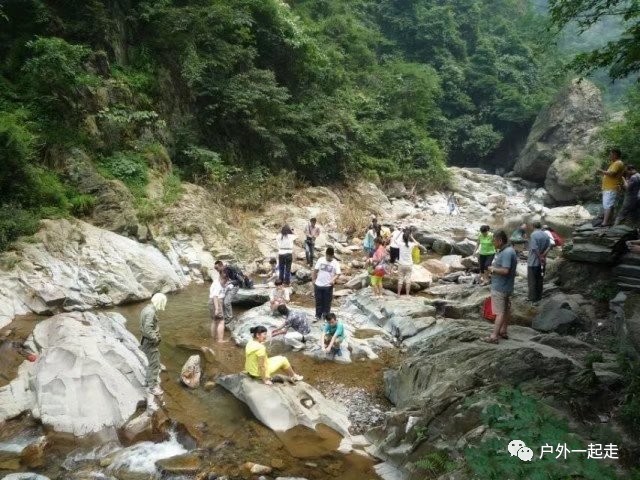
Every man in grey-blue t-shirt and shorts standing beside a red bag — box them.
[482,230,516,343]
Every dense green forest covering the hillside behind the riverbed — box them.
[0,0,592,247]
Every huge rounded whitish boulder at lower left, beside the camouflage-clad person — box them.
[0,312,147,437]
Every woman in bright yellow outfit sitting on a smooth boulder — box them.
[244,325,303,385]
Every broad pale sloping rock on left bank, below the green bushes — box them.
[0,220,188,326]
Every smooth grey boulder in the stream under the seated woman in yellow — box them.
[216,374,351,437]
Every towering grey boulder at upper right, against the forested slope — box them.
[514,80,605,183]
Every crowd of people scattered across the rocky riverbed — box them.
[140,149,640,408]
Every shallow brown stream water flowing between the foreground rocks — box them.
[0,285,399,480]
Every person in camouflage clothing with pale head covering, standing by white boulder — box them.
[140,293,167,411]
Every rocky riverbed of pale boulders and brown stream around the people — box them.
[0,168,636,480]
